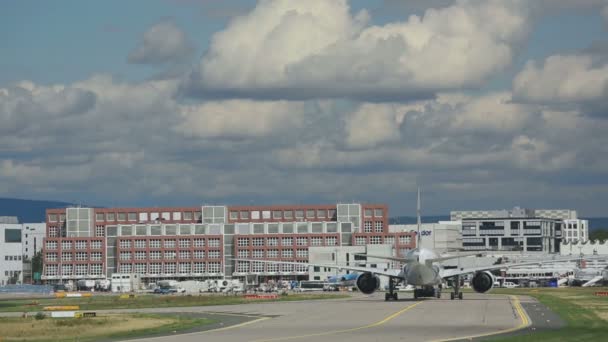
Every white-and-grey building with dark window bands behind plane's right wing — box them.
[450,207,564,253]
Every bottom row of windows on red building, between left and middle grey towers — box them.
[118,261,222,274]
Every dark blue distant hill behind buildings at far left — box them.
[0,198,73,223]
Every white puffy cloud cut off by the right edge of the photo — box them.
[513,55,608,104]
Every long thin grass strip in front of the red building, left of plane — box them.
[0,294,349,312]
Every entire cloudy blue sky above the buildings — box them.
[0,0,608,217]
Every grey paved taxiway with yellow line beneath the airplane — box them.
[121,293,530,342]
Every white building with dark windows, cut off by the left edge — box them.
[0,223,23,286]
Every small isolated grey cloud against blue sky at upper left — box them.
[127,20,194,64]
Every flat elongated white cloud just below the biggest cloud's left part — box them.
[175,100,305,138]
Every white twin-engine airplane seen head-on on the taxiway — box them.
[233,189,596,301]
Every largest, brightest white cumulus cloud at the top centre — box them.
[183,0,529,100]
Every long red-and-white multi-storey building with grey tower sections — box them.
[42,203,415,283]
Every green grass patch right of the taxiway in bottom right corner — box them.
[490,288,608,342]
